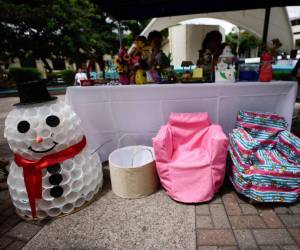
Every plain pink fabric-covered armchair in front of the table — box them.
[153,113,228,203]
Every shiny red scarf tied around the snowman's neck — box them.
[15,136,86,218]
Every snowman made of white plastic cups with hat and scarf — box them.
[4,81,103,219]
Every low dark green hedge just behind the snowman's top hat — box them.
[9,67,42,82]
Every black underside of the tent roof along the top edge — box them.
[99,0,299,20]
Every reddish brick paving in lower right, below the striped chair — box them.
[195,180,300,249]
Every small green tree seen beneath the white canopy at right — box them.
[226,31,261,57]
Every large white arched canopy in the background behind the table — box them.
[141,7,294,51]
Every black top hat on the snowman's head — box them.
[14,80,57,106]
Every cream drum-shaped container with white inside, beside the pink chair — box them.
[108,146,159,198]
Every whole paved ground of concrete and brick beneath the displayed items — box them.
[0,98,300,250]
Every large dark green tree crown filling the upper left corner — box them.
[0,0,118,72]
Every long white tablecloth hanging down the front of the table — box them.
[66,82,297,161]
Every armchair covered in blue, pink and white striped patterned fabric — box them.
[229,111,300,202]
